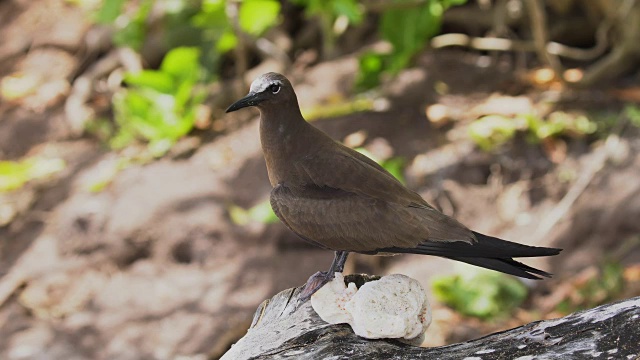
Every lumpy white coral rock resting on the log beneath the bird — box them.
[311,273,431,343]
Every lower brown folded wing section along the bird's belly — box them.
[271,185,429,253]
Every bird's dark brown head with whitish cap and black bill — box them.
[227,72,297,112]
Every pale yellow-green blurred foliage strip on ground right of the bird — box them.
[469,111,598,151]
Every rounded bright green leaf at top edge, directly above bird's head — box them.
[238,0,280,36]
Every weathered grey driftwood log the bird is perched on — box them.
[222,275,640,360]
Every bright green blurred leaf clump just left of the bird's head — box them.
[111,47,206,156]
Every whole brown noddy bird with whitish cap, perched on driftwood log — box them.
[227,73,561,300]
